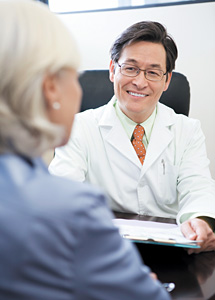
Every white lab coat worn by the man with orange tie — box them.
[49,98,215,222]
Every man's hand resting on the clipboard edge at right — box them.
[181,218,215,254]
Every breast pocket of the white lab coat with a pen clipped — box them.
[158,159,179,204]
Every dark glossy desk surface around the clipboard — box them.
[114,212,215,300]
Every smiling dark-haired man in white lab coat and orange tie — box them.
[50,22,215,252]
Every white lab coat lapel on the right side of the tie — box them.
[142,103,175,175]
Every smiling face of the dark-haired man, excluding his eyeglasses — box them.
[110,41,172,123]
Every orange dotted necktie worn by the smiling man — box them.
[131,125,146,164]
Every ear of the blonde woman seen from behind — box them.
[42,75,60,107]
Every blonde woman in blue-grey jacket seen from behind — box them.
[0,0,169,300]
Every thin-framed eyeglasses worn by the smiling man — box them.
[117,63,167,81]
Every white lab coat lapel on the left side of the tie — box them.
[99,98,142,168]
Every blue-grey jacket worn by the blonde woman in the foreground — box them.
[0,154,169,300]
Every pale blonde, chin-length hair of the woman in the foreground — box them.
[0,0,79,156]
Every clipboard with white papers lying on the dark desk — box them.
[113,219,200,248]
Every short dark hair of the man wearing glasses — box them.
[110,21,178,73]
